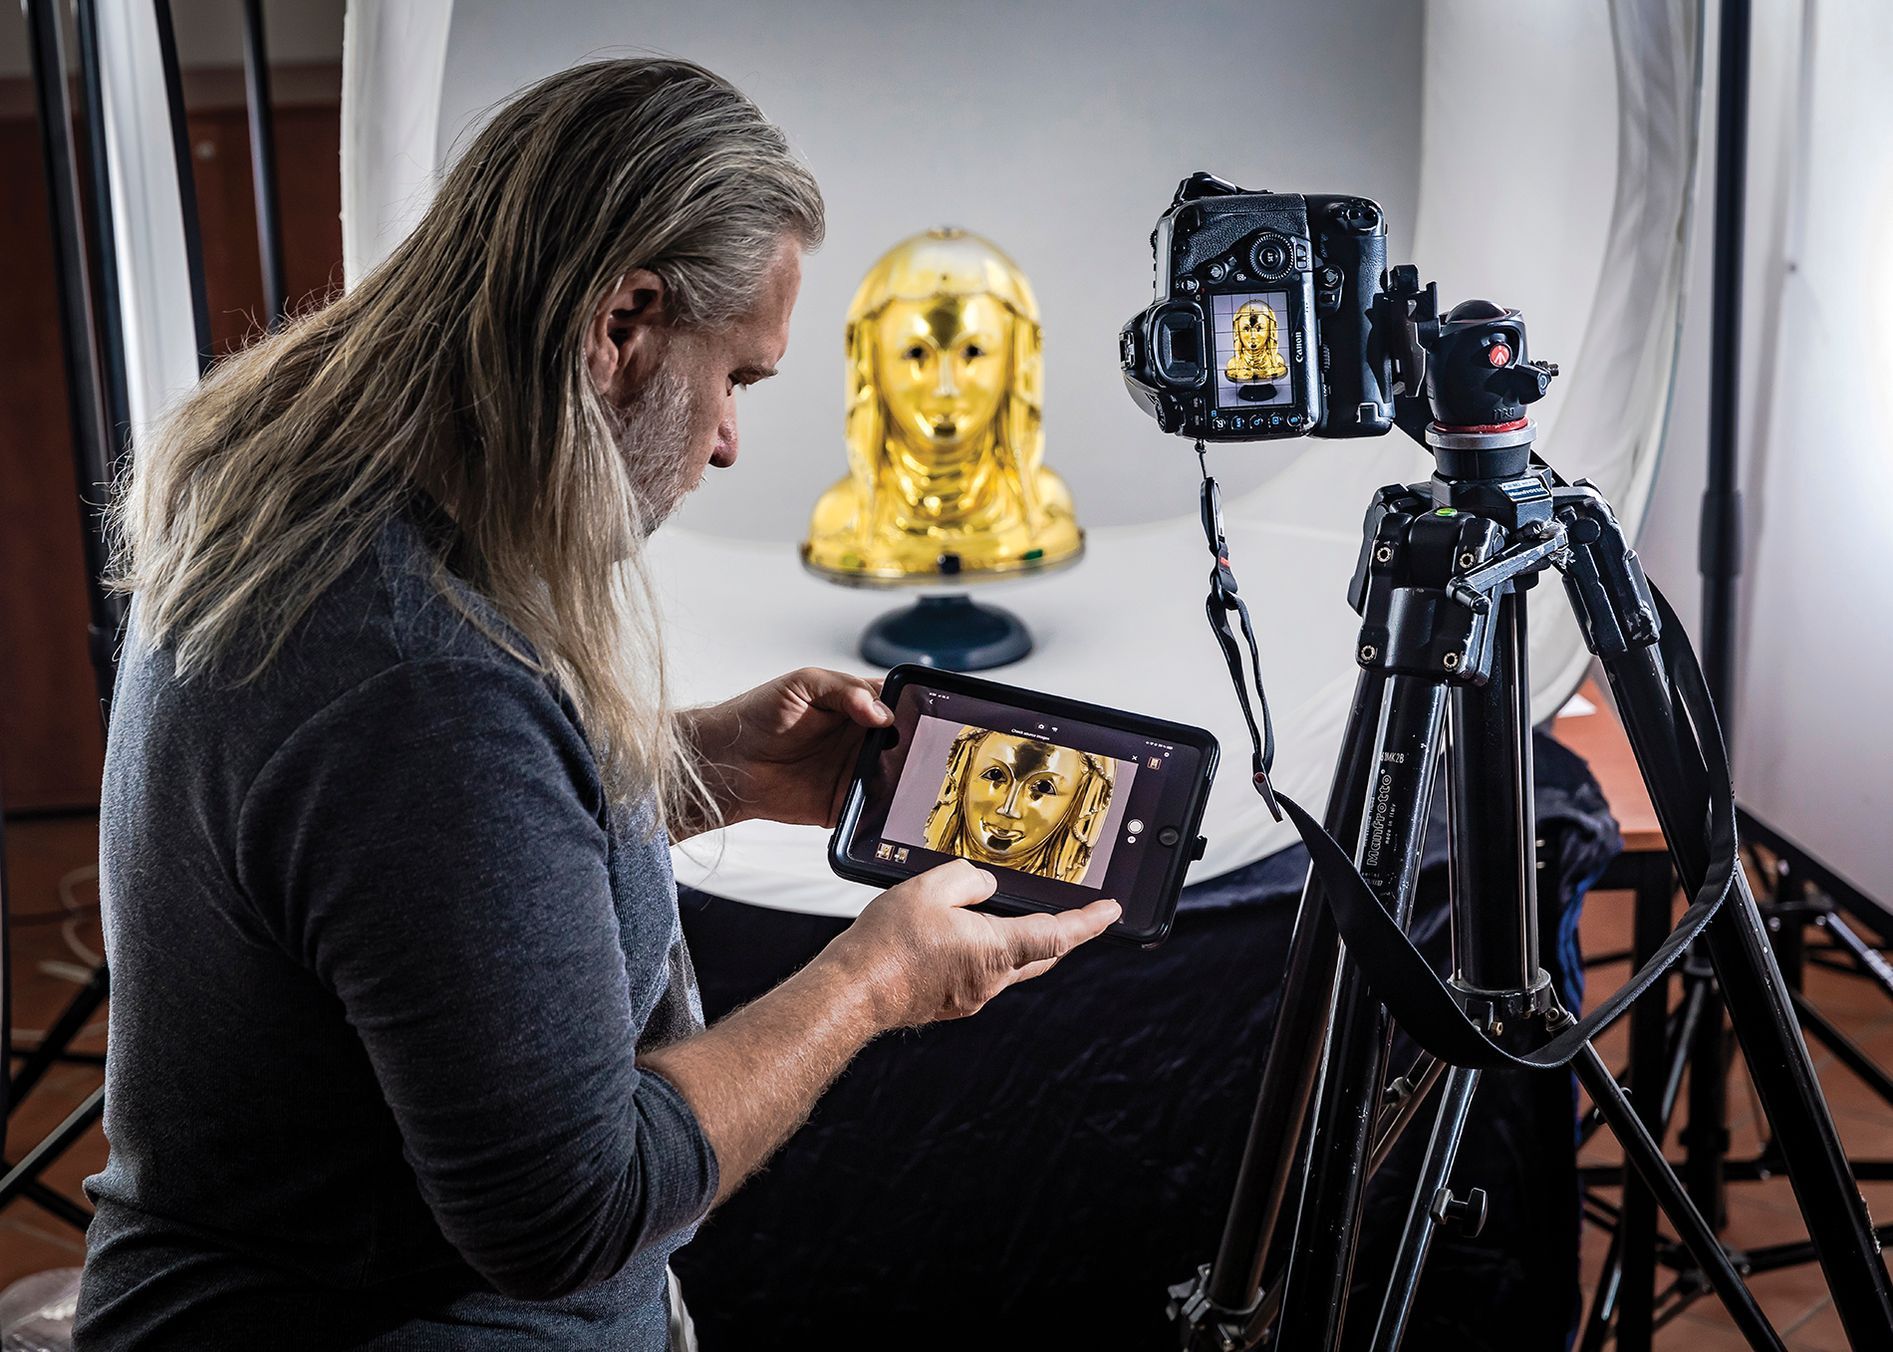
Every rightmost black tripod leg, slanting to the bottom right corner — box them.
[1603,648,1893,1346]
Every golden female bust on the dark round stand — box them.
[803,229,1085,585]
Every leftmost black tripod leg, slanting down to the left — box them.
[1206,672,1386,1310]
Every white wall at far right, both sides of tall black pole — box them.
[1639,0,1893,903]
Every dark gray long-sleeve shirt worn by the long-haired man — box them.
[76,517,716,1350]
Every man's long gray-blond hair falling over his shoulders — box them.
[114,59,823,822]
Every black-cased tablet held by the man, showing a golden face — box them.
[829,667,1219,947]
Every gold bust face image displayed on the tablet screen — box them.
[924,727,1117,882]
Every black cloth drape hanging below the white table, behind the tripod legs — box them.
[674,735,1620,1352]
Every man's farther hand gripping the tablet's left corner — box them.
[674,667,893,839]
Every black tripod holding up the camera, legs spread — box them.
[1172,287,1893,1352]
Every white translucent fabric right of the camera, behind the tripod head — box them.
[1414,0,1702,720]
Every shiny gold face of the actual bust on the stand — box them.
[875,295,1011,458]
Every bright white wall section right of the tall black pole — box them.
[1732,4,1893,905]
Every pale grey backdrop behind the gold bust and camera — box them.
[441,0,1422,537]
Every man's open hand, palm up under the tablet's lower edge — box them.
[816,860,1123,1028]
